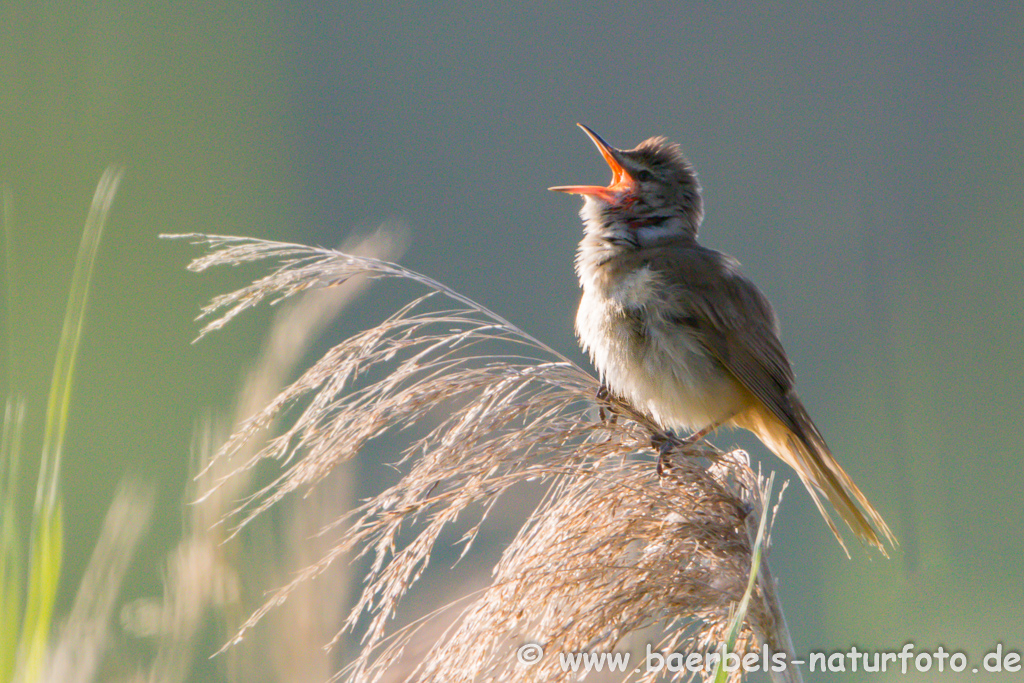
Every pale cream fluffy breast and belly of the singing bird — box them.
[577,266,748,430]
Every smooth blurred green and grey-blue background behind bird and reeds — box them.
[0,0,1024,681]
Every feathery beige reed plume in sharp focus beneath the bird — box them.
[173,234,800,682]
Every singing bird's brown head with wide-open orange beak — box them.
[551,124,703,247]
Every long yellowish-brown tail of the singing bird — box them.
[742,396,898,557]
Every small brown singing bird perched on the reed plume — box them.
[550,124,897,556]
